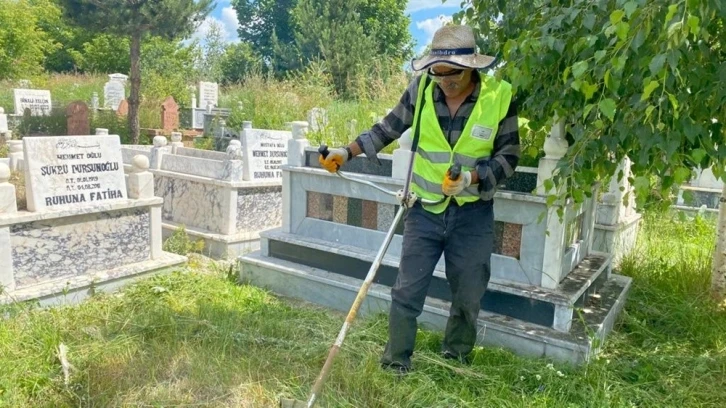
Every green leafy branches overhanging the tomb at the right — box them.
[464,0,726,291]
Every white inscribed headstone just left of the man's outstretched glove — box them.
[242,129,292,181]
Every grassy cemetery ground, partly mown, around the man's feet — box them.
[0,209,726,407]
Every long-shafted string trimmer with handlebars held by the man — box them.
[280,145,461,408]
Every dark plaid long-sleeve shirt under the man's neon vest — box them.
[356,73,521,201]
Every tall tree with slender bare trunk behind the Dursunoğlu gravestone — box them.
[59,0,214,143]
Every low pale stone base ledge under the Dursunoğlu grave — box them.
[0,252,187,307]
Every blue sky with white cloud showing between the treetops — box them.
[194,0,461,53]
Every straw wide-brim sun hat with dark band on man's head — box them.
[411,25,496,71]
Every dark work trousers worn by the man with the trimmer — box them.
[381,200,494,368]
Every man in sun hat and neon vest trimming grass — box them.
[320,25,520,373]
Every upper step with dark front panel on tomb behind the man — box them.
[260,229,610,332]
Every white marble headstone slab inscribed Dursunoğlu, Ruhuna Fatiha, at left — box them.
[23,135,127,211]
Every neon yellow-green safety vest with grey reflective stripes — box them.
[411,73,512,213]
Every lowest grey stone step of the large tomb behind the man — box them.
[239,251,631,364]
